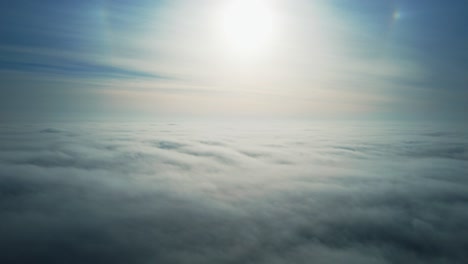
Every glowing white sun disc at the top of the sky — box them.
[218,0,275,56]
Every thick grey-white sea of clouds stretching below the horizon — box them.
[0,122,468,264]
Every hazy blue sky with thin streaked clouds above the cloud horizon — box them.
[0,0,468,120]
